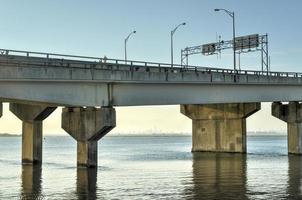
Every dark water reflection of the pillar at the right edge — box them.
[287,155,302,199]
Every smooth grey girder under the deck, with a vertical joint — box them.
[0,80,302,107]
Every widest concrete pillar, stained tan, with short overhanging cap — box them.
[181,103,261,153]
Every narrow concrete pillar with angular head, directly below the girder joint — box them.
[62,107,116,167]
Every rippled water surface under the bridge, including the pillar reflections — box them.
[0,136,302,199]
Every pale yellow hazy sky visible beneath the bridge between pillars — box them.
[0,103,287,135]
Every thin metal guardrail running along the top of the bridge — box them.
[0,49,302,78]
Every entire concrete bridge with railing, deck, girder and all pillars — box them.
[0,49,302,167]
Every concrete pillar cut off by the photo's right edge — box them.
[272,102,302,154]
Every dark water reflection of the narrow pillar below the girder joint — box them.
[77,168,97,199]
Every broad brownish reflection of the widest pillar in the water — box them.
[186,153,247,199]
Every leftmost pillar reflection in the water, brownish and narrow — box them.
[21,165,43,199]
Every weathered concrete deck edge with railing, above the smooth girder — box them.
[0,49,302,84]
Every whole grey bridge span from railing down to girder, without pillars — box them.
[0,49,302,106]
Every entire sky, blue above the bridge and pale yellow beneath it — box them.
[0,0,302,134]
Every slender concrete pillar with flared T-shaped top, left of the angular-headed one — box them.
[9,103,56,164]
